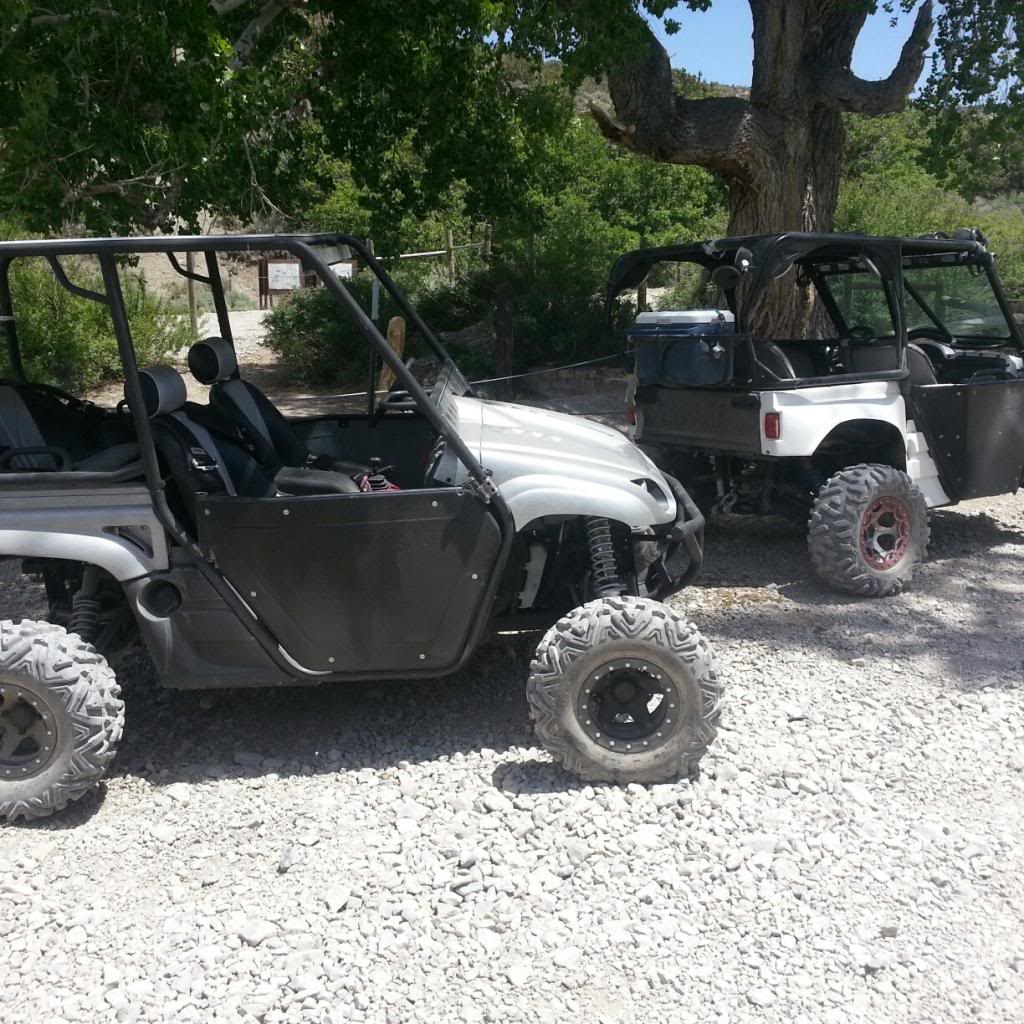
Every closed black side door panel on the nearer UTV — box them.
[198,487,503,675]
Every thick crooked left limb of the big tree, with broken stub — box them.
[590,17,750,176]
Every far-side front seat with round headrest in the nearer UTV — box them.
[188,338,370,476]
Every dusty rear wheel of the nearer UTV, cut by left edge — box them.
[0,620,124,821]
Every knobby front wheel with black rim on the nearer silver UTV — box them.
[526,597,722,783]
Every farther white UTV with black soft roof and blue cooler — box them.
[608,229,1024,596]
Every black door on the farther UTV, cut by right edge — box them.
[911,380,1024,501]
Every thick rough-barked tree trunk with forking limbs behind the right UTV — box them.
[591,0,932,339]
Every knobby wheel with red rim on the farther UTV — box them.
[807,464,929,597]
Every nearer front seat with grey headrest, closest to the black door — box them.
[139,367,359,526]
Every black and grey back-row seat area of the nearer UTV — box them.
[0,381,142,471]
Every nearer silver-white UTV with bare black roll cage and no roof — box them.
[0,236,721,819]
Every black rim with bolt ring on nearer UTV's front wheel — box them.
[577,657,680,754]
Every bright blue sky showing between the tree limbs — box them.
[656,0,928,86]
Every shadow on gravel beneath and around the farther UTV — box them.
[692,506,1024,691]
